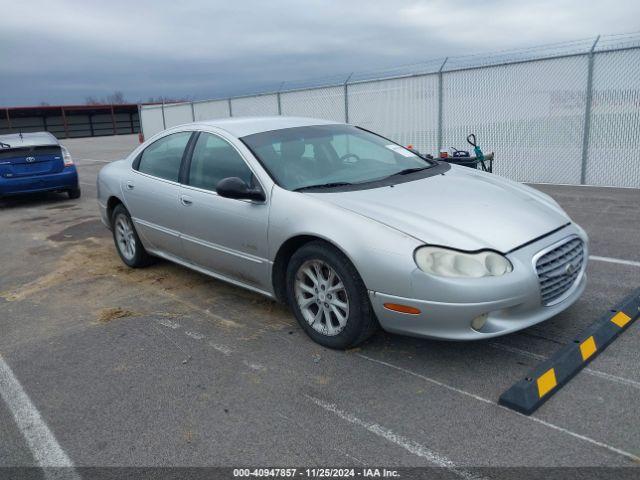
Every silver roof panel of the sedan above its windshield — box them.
[195,116,340,138]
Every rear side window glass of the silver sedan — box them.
[138,132,192,182]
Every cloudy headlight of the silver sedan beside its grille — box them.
[415,247,513,278]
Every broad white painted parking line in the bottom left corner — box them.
[0,356,80,479]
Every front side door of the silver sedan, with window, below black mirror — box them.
[180,132,270,291]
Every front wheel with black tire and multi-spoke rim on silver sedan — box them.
[286,241,378,350]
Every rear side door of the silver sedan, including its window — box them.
[122,131,193,257]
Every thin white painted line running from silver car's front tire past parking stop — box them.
[355,353,640,462]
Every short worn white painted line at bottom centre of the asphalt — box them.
[305,394,482,479]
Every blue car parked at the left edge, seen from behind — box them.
[0,132,80,198]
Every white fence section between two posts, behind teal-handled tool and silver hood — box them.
[442,55,587,184]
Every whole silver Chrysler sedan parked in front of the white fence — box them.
[98,117,588,348]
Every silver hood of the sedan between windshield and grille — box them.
[310,166,571,253]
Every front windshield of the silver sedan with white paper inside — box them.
[241,125,435,190]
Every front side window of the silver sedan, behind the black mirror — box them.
[187,132,253,191]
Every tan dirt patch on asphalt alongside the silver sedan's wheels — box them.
[0,234,295,340]
